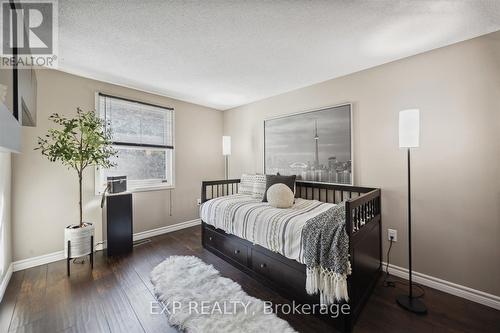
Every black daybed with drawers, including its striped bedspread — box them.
[201,179,382,332]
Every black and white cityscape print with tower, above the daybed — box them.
[264,104,352,184]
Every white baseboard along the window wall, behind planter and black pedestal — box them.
[11,219,201,274]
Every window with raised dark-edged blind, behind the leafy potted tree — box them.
[96,94,174,192]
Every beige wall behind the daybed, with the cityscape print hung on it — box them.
[224,32,500,295]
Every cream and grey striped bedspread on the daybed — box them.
[200,194,335,263]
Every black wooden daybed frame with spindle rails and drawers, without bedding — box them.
[201,179,382,332]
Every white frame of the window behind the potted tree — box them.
[95,91,175,195]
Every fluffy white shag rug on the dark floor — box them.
[151,256,295,333]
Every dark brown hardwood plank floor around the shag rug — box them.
[0,227,500,333]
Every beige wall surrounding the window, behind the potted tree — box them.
[12,70,224,260]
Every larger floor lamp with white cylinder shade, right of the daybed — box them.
[396,109,427,314]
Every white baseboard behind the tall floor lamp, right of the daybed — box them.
[382,262,500,310]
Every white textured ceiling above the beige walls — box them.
[59,0,500,110]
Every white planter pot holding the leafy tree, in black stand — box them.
[64,222,94,258]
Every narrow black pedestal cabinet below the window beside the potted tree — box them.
[106,193,133,256]
